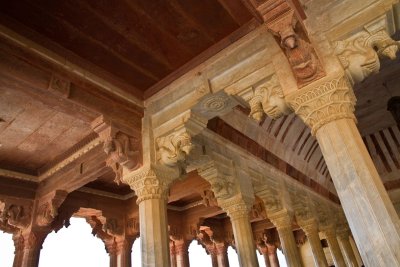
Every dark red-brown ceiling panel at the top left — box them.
[0,0,254,98]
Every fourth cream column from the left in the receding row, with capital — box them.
[300,220,328,267]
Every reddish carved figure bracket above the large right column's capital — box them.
[267,10,325,87]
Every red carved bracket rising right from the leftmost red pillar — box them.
[36,190,68,226]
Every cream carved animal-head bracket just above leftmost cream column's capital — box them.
[156,131,193,167]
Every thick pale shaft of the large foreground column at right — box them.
[316,119,400,266]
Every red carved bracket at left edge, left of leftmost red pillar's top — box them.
[0,201,32,229]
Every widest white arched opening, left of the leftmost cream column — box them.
[39,218,110,267]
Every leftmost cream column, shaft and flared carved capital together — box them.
[124,165,180,267]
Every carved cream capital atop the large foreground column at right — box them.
[286,76,356,135]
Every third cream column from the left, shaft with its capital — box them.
[268,214,302,267]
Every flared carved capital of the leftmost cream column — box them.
[123,164,181,204]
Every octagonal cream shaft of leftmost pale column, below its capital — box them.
[139,197,170,267]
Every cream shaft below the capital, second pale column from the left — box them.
[231,217,258,267]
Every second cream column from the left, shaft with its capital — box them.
[222,201,258,267]
